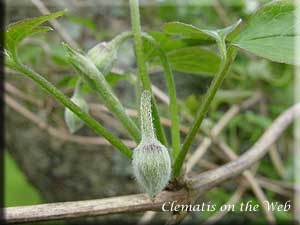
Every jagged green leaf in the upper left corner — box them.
[5,10,66,59]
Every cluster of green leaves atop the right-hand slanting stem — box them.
[162,0,300,75]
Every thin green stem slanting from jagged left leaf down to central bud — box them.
[14,63,132,159]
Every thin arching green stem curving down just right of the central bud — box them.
[142,33,180,160]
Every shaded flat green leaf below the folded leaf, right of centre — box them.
[156,47,221,75]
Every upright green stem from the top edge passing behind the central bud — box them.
[129,0,167,145]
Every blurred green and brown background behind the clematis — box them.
[5,0,293,223]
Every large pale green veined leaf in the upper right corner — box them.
[232,0,300,64]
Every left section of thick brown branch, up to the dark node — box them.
[4,190,188,223]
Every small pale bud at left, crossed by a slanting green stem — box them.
[65,81,89,134]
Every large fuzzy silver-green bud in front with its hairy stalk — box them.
[132,91,171,198]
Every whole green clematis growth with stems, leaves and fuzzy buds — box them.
[4,0,299,198]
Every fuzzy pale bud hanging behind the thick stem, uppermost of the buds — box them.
[87,41,118,75]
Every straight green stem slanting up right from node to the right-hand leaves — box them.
[173,46,237,177]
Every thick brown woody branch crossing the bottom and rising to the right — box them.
[4,104,300,223]
